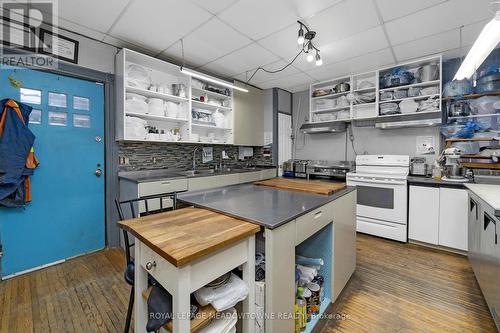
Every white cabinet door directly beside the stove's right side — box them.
[408,186,439,245]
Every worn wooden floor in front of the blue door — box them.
[0,250,130,333]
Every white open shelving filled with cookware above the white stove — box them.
[309,56,442,123]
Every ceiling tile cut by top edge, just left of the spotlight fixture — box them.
[219,0,299,40]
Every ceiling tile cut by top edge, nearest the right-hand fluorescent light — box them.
[386,0,492,45]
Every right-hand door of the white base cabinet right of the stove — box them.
[439,188,468,251]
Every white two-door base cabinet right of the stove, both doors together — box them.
[408,186,469,251]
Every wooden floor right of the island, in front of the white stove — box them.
[315,234,497,333]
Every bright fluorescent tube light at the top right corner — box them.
[453,1,500,80]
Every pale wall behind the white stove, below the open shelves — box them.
[293,91,440,162]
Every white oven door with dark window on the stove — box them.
[347,176,407,224]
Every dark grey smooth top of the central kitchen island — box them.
[178,184,356,229]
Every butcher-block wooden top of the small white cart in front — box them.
[118,208,260,267]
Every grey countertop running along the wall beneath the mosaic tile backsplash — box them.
[118,166,276,183]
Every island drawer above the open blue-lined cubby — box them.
[295,203,333,244]
